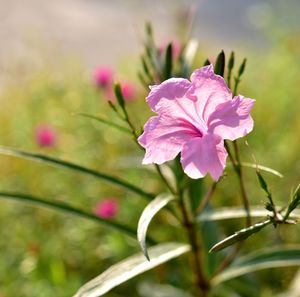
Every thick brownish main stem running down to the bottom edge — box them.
[178,188,209,297]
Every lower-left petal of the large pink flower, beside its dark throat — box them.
[138,116,201,164]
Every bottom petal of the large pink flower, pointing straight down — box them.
[181,134,227,181]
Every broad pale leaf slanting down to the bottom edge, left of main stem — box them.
[74,242,190,297]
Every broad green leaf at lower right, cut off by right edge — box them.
[212,245,300,285]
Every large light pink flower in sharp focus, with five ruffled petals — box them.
[138,65,255,180]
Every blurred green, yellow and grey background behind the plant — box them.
[0,0,300,297]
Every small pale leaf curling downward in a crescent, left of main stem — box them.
[137,194,175,261]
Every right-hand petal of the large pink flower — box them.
[208,95,255,140]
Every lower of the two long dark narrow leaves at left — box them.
[0,192,146,243]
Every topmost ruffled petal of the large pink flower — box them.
[187,64,232,122]
